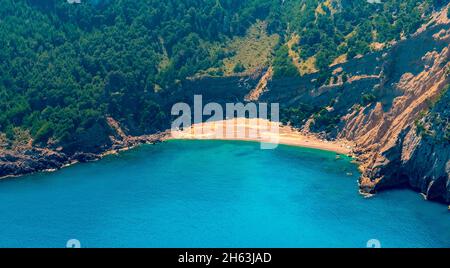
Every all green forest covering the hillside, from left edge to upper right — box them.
[0,0,441,150]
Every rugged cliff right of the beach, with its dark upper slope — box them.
[260,6,450,203]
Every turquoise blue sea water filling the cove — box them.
[0,141,450,247]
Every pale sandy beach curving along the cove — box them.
[168,118,353,155]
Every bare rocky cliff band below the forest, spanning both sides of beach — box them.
[0,1,450,203]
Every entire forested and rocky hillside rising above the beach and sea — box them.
[0,0,450,203]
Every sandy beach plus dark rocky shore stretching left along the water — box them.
[0,118,354,179]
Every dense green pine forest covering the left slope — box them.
[0,0,278,151]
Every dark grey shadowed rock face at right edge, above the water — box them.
[373,91,450,203]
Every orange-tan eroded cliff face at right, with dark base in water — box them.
[350,25,450,203]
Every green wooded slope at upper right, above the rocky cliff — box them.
[269,0,443,77]
